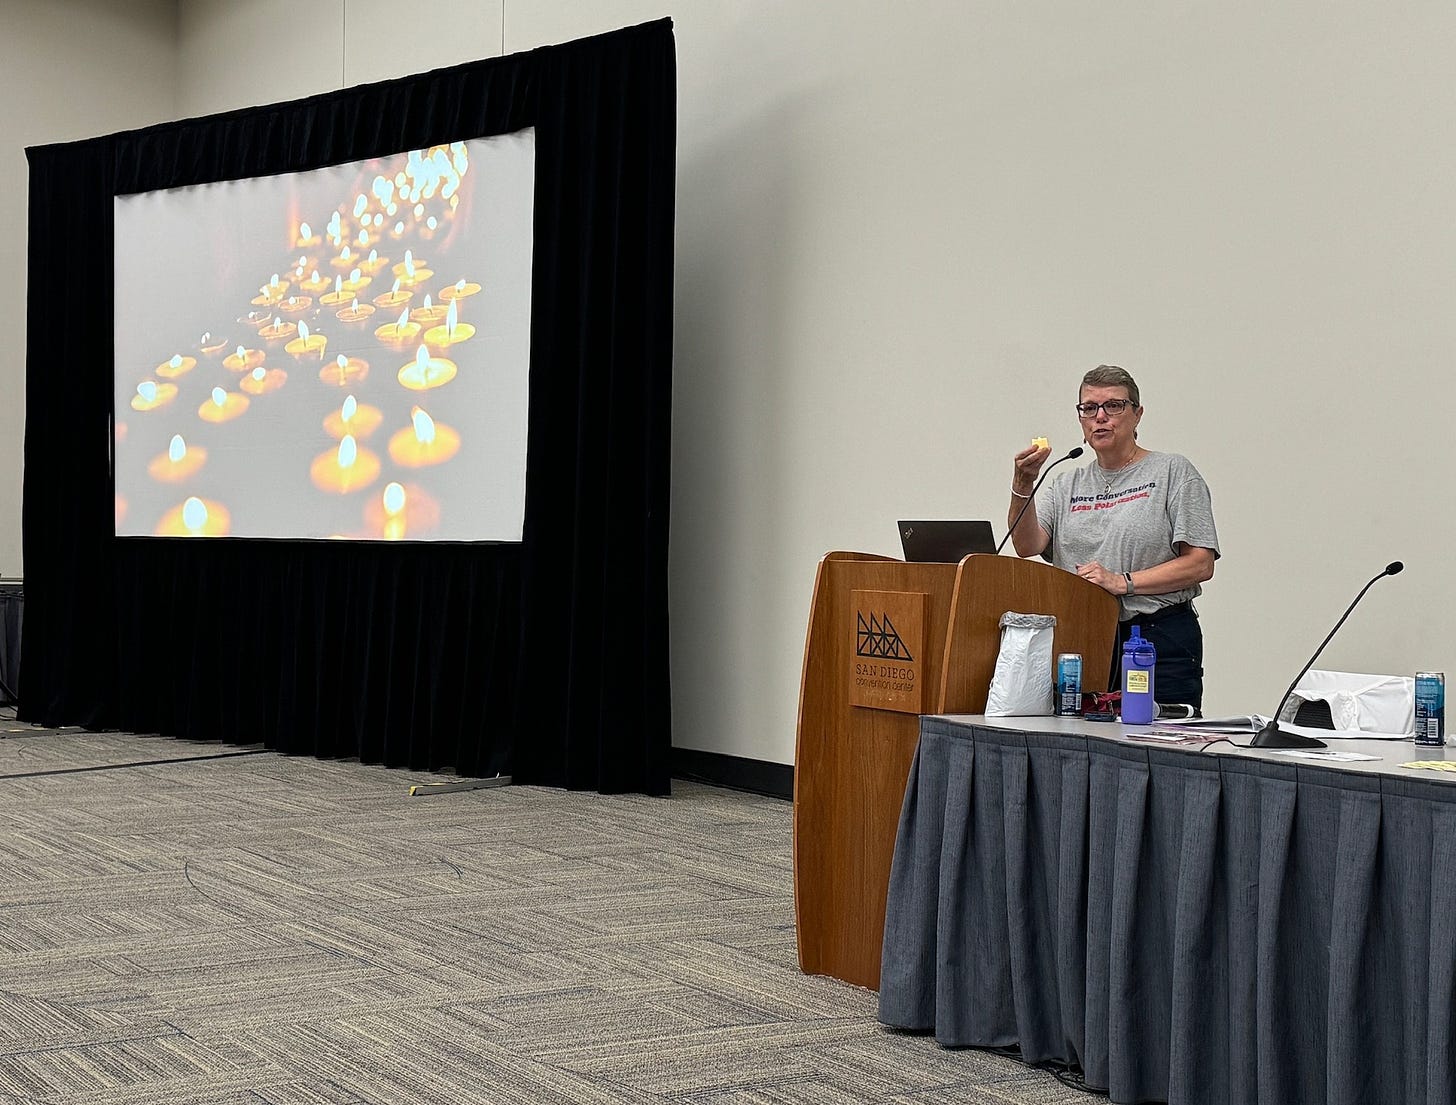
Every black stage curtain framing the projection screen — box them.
[20,20,677,793]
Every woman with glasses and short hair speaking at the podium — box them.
[1006,364,1219,708]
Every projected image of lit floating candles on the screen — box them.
[114,130,534,542]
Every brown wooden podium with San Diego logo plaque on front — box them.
[794,552,1118,990]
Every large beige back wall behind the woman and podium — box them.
[0,0,1456,761]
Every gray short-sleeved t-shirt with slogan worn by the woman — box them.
[1037,453,1220,620]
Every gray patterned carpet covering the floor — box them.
[0,721,1096,1105]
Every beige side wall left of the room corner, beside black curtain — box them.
[0,0,176,577]
